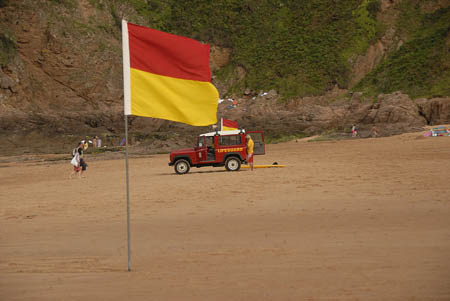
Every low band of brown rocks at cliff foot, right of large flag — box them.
[220,92,450,137]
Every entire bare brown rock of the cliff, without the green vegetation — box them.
[0,0,450,154]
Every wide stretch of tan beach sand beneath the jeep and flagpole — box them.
[0,133,450,300]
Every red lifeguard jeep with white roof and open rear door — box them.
[169,130,266,175]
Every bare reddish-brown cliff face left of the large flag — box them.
[0,1,122,134]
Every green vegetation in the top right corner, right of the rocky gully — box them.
[355,1,450,98]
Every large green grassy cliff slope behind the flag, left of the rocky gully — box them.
[117,0,380,98]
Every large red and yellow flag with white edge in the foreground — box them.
[122,20,219,126]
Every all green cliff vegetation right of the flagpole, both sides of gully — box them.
[129,0,450,98]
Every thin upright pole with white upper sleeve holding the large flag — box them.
[122,20,131,271]
